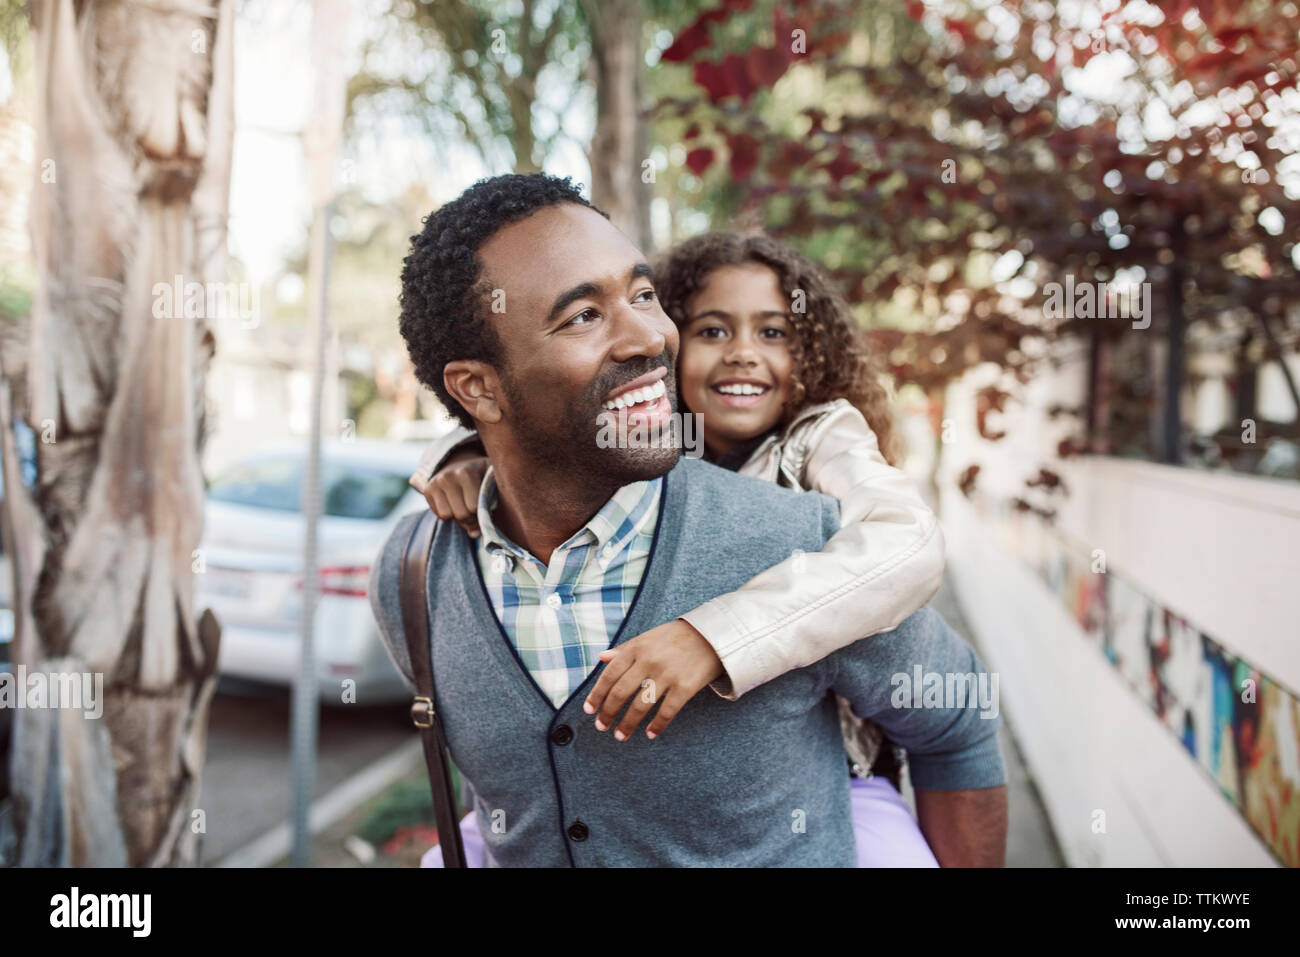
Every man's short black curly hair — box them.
[398,173,608,429]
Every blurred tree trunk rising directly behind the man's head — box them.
[582,0,654,252]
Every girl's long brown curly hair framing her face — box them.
[654,233,900,465]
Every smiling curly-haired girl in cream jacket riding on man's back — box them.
[411,233,944,867]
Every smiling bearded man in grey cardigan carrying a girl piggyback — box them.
[369,174,1005,866]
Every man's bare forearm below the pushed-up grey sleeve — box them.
[917,787,1006,867]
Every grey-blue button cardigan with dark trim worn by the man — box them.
[369,458,1006,867]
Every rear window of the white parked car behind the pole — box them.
[208,456,410,519]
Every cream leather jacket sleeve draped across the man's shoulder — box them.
[680,403,944,700]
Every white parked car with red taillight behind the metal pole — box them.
[195,438,428,705]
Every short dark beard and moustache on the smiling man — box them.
[503,352,681,488]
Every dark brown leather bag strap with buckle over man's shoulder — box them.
[398,510,467,867]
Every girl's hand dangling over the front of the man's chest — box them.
[582,619,723,741]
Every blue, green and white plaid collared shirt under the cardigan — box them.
[476,467,663,707]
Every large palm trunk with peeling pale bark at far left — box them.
[0,0,234,866]
